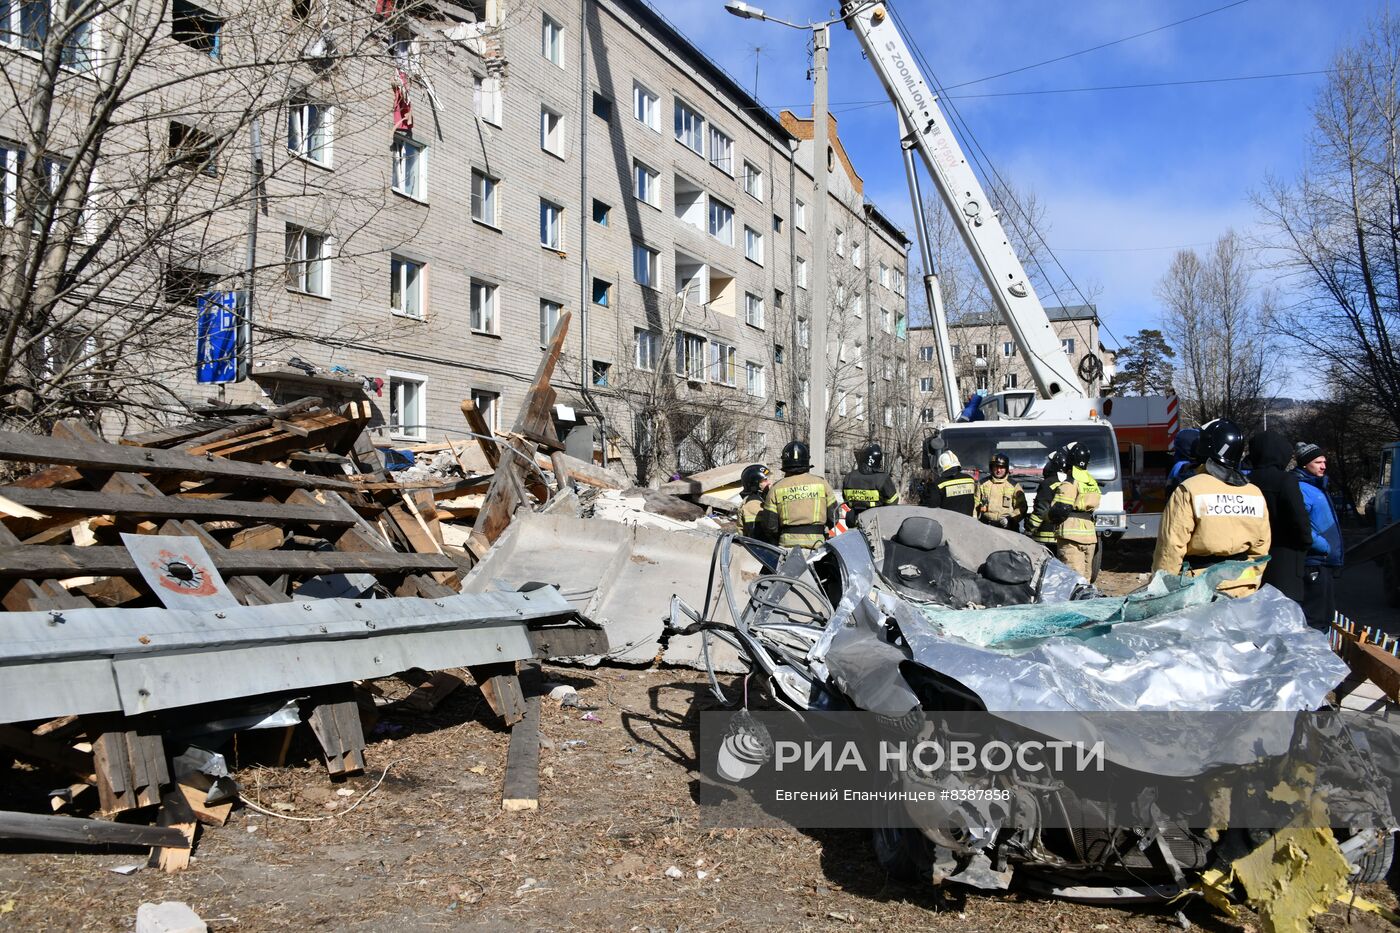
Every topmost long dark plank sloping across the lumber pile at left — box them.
[0,431,354,492]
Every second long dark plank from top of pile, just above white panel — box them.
[4,488,350,525]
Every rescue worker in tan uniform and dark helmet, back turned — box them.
[1152,417,1271,597]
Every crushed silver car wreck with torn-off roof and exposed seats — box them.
[661,506,1400,913]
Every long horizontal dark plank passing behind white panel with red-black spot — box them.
[0,540,459,577]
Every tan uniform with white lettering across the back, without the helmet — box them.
[1152,472,1273,597]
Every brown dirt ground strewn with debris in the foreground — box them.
[0,537,1396,933]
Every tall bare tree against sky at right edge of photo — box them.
[1256,10,1400,433]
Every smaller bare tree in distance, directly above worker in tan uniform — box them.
[1156,231,1275,429]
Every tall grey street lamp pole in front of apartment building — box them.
[724,0,833,475]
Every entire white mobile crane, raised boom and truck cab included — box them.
[841,1,1127,540]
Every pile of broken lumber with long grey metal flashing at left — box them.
[0,322,616,870]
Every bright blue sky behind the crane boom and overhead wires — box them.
[654,0,1385,355]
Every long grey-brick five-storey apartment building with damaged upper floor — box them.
[0,0,917,479]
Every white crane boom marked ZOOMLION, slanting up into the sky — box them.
[843,1,1086,399]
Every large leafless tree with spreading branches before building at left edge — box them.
[0,0,482,430]
